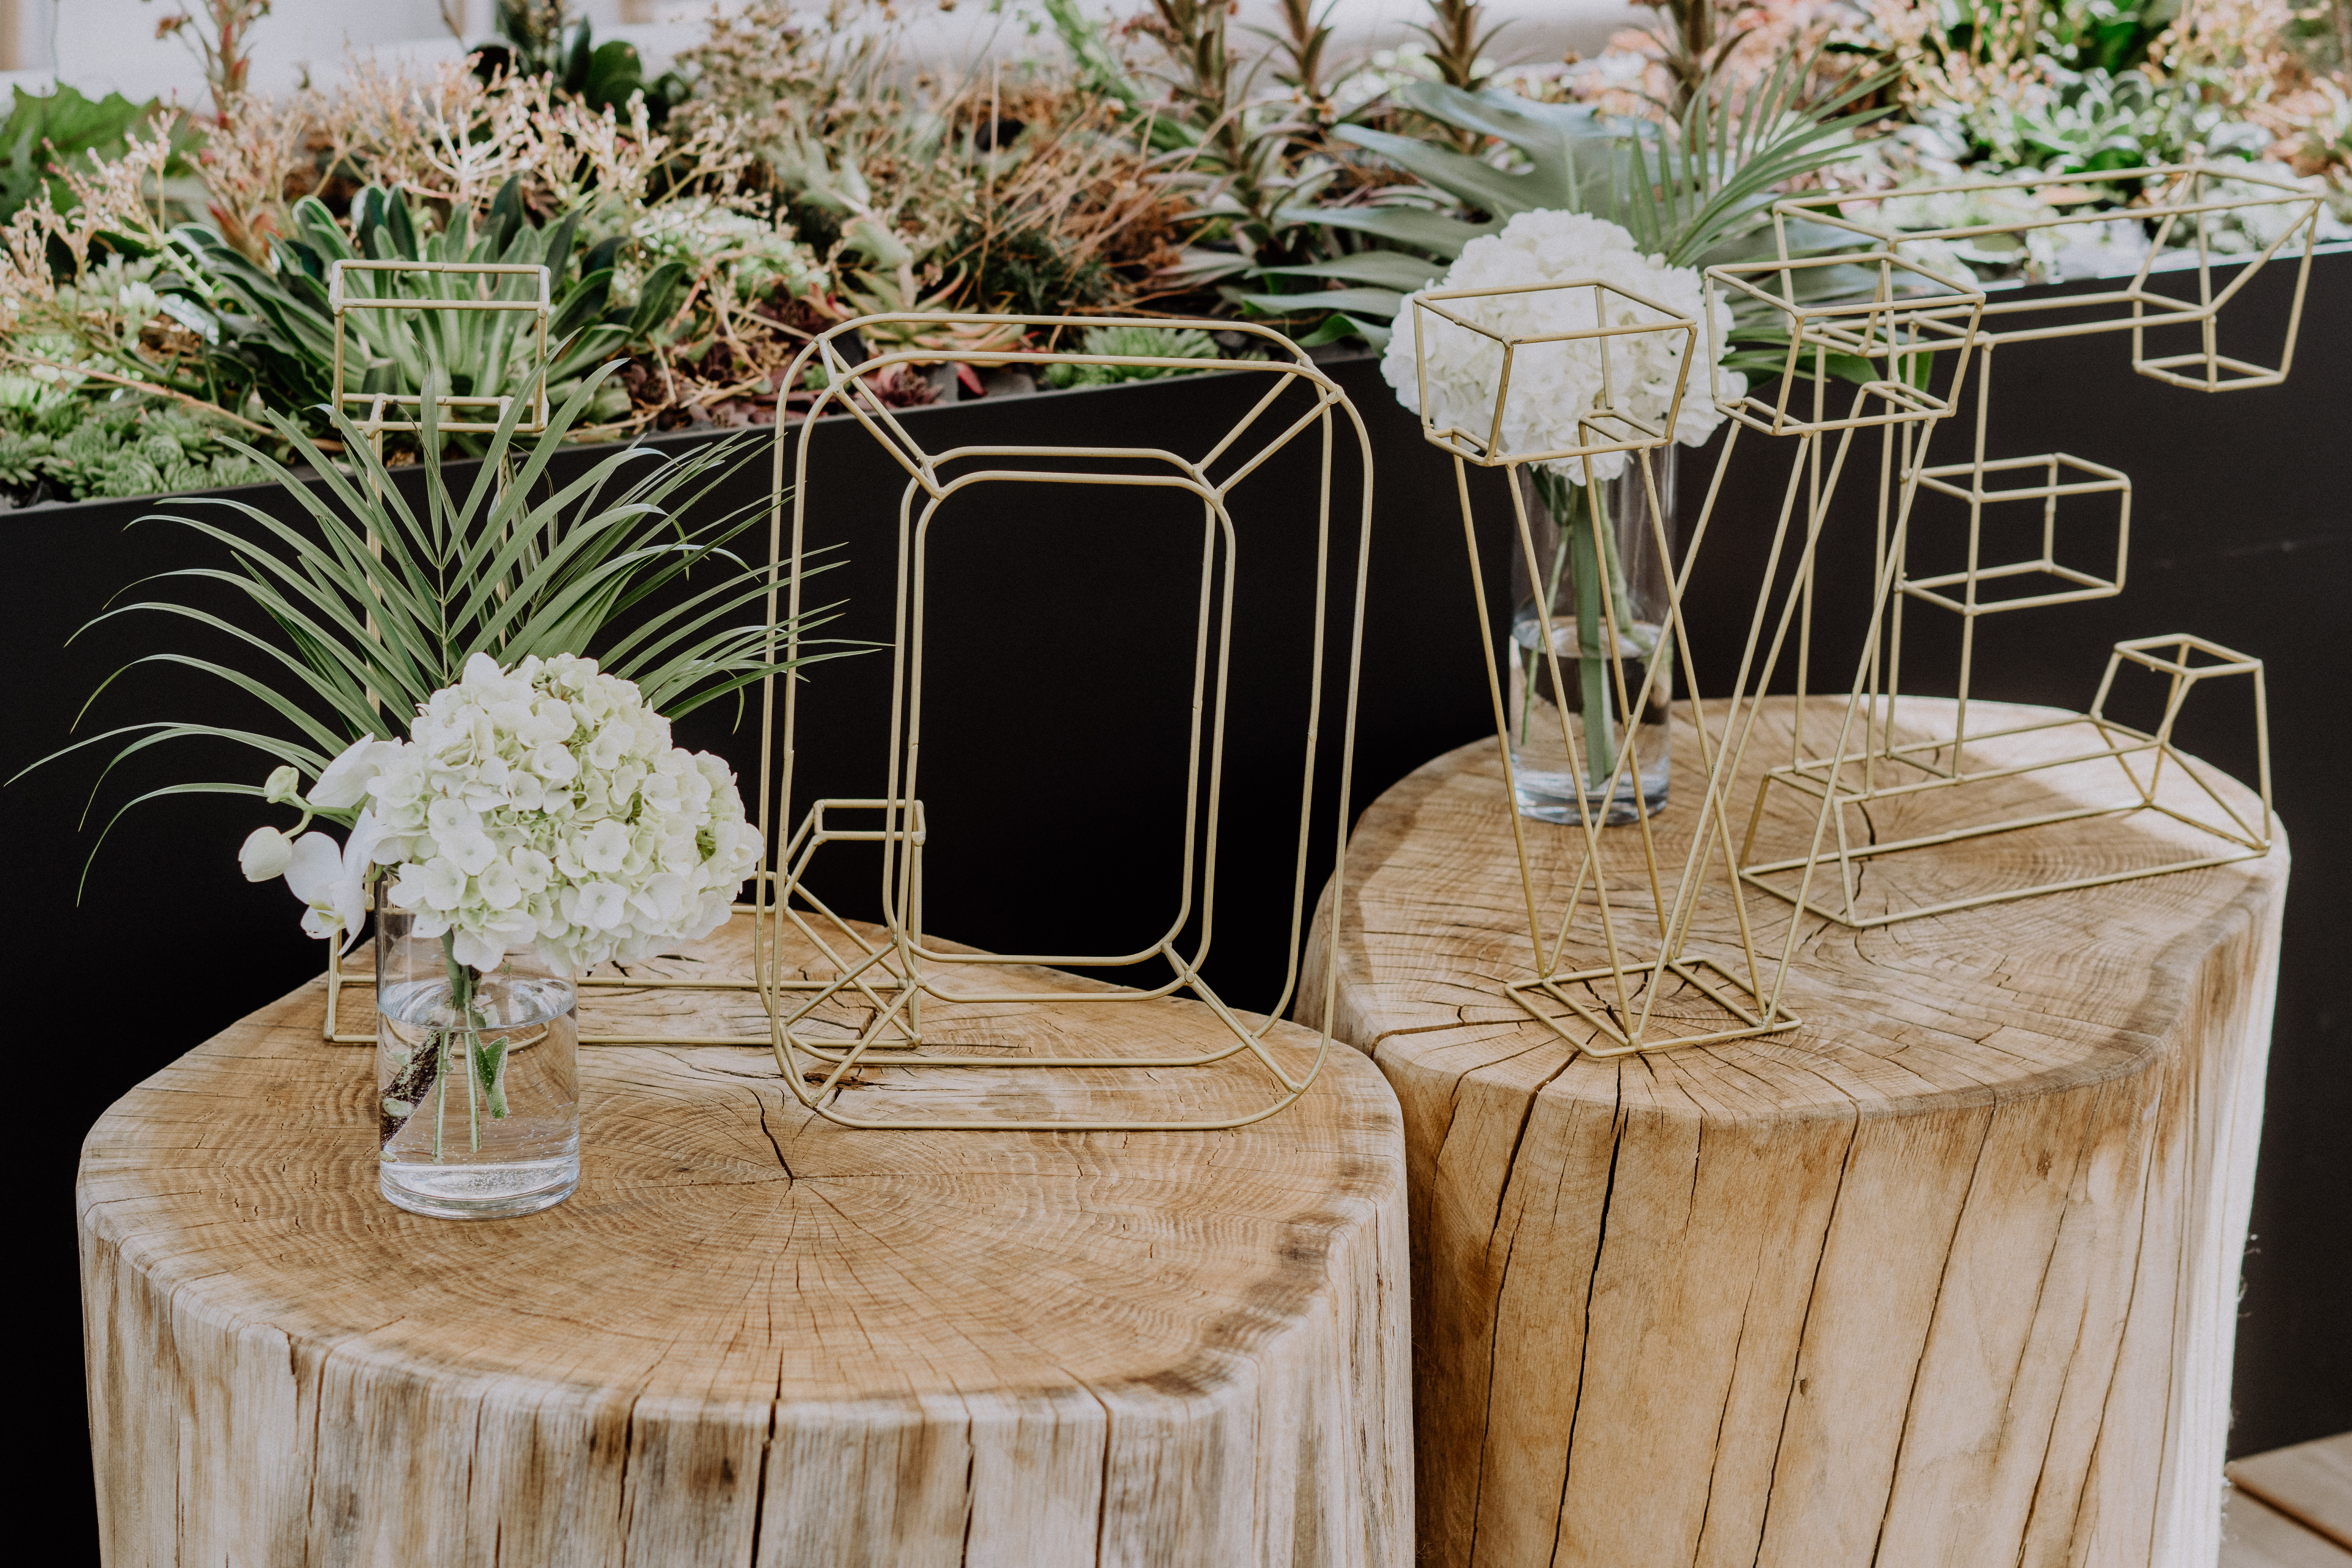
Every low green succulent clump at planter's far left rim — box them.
[0,376,263,501]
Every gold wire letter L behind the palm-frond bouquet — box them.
[320,261,774,1046]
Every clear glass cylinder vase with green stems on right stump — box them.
[1505,446,1675,823]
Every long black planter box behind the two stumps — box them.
[23,254,2352,1552]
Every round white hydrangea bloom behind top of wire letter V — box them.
[1381,209,1748,484]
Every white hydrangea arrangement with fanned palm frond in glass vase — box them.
[46,367,842,1218]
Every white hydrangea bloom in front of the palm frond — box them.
[283,653,764,971]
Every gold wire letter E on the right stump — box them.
[1740,165,2319,929]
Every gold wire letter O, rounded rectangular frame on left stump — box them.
[753,313,1371,1131]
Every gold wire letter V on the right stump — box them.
[1414,267,1983,1058]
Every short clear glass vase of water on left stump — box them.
[376,884,581,1220]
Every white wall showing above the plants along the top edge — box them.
[0,0,1649,106]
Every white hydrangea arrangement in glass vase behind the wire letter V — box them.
[1381,209,1748,820]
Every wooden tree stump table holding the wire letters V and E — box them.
[1301,701,2286,1568]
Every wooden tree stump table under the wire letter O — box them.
[80,917,1411,1568]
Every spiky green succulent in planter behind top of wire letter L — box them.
[167,181,684,449]
